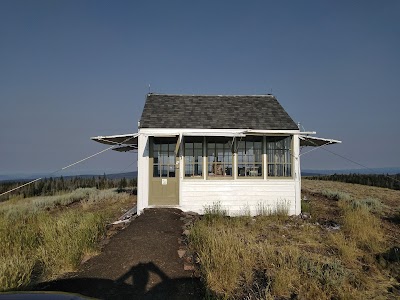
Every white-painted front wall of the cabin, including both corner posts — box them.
[137,130,301,215]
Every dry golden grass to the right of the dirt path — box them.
[190,181,396,299]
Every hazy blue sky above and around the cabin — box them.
[0,0,400,175]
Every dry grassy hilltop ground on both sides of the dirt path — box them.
[0,180,400,299]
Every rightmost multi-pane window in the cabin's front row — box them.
[267,136,292,177]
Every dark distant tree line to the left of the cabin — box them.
[0,175,137,201]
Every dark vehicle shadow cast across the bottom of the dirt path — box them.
[33,262,204,299]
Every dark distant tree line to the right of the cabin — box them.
[307,174,400,190]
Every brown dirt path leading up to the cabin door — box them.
[37,208,203,299]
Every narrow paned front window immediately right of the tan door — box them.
[184,137,203,177]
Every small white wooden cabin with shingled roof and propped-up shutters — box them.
[92,94,339,215]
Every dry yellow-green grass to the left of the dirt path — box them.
[0,189,133,291]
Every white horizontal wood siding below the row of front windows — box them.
[180,179,296,215]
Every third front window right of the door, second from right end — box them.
[237,136,263,178]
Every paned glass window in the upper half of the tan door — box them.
[153,138,176,177]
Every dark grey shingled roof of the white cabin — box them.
[140,94,298,130]
